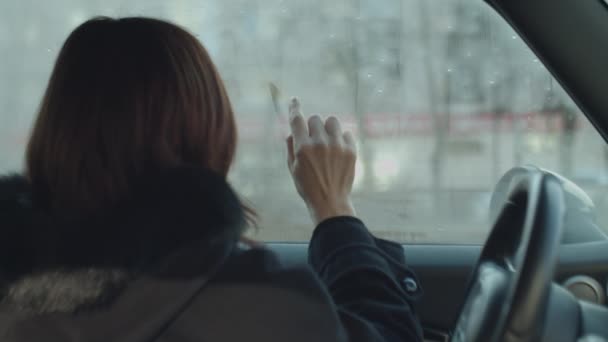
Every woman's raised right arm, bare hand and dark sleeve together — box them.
[287,99,422,341]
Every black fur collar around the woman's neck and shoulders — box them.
[0,168,245,313]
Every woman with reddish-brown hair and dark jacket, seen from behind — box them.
[0,18,421,342]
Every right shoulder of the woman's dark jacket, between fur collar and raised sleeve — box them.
[166,249,347,342]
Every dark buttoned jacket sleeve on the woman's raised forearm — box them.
[309,217,423,342]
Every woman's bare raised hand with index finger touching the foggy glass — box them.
[287,98,357,224]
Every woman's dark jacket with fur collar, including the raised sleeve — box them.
[0,168,422,342]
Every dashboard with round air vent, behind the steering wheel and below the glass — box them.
[268,168,608,341]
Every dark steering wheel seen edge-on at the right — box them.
[451,167,565,342]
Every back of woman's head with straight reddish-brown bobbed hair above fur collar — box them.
[26,18,237,213]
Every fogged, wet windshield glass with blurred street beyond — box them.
[0,0,608,243]
